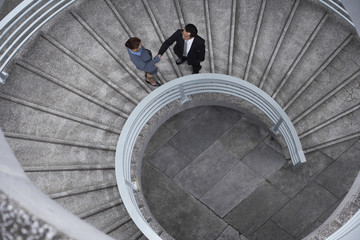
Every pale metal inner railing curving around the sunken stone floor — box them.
[115,73,306,240]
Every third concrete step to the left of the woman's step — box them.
[0,65,129,129]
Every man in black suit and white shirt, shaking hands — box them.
[158,24,205,73]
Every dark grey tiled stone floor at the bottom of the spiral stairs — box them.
[141,106,360,240]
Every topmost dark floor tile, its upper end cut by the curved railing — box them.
[169,107,241,160]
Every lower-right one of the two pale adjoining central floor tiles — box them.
[201,162,264,217]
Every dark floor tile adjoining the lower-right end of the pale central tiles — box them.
[224,182,290,236]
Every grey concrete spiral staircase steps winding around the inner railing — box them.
[0,0,360,240]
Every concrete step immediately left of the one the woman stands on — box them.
[41,10,150,96]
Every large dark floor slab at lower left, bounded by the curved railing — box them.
[142,162,227,240]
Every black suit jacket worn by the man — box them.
[159,29,205,65]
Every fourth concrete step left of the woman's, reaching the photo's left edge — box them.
[0,100,118,146]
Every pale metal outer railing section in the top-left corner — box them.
[0,0,76,83]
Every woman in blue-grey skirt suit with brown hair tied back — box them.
[125,37,161,87]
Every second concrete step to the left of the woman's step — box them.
[13,35,139,110]
